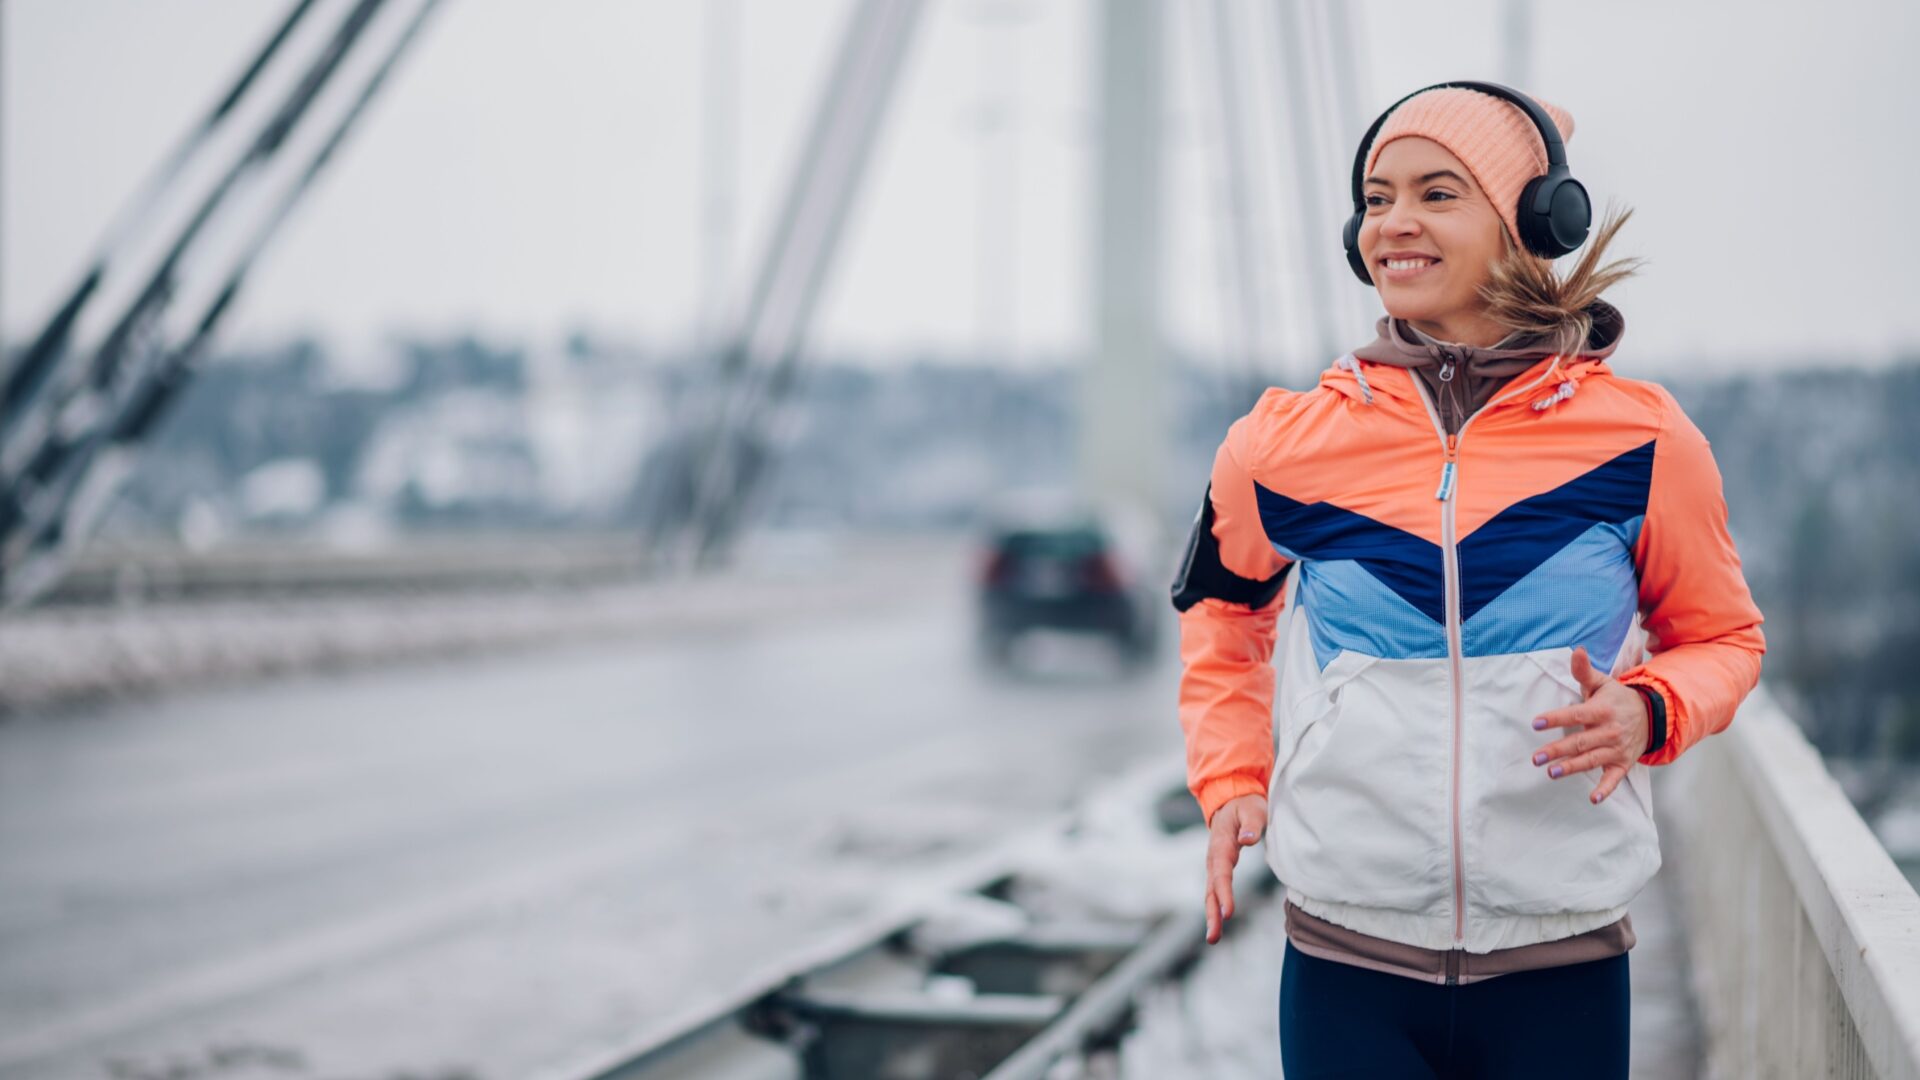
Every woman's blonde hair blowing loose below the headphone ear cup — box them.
[1480,197,1645,356]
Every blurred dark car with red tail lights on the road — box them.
[977,498,1171,667]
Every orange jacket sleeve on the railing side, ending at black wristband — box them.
[1620,388,1766,765]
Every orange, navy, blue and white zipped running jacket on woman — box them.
[1175,340,1766,953]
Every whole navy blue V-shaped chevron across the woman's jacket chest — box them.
[1254,440,1653,625]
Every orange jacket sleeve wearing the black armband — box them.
[1175,417,1288,822]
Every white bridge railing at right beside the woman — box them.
[1657,684,1920,1080]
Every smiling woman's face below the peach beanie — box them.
[1359,135,1505,340]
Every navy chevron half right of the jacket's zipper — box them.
[1459,440,1653,623]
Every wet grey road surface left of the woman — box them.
[0,553,1200,1080]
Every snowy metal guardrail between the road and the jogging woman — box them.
[538,761,1273,1080]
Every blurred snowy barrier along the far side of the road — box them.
[0,534,964,715]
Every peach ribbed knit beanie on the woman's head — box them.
[1367,86,1572,248]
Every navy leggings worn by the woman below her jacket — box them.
[1281,942,1630,1080]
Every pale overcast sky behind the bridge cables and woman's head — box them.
[0,0,1920,375]
